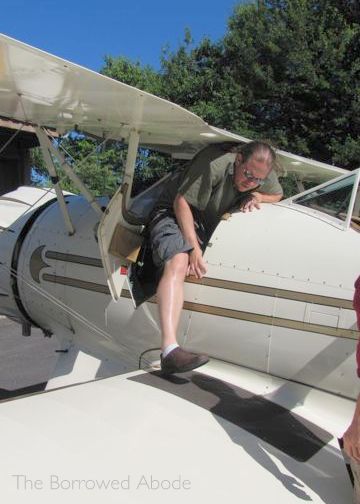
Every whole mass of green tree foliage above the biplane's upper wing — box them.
[100,0,360,168]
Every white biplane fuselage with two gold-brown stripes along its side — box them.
[0,173,360,397]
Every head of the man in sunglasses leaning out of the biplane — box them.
[234,142,276,192]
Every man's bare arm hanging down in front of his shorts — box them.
[174,194,207,278]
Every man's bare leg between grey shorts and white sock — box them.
[157,253,189,350]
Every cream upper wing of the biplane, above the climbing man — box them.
[0,34,345,183]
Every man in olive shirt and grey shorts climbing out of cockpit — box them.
[149,142,282,374]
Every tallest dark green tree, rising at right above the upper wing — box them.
[224,0,360,168]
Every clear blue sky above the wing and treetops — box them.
[0,0,241,70]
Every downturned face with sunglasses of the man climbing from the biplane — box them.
[234,153,271,192]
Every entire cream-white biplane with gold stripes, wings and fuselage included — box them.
[0,35,360,504]
